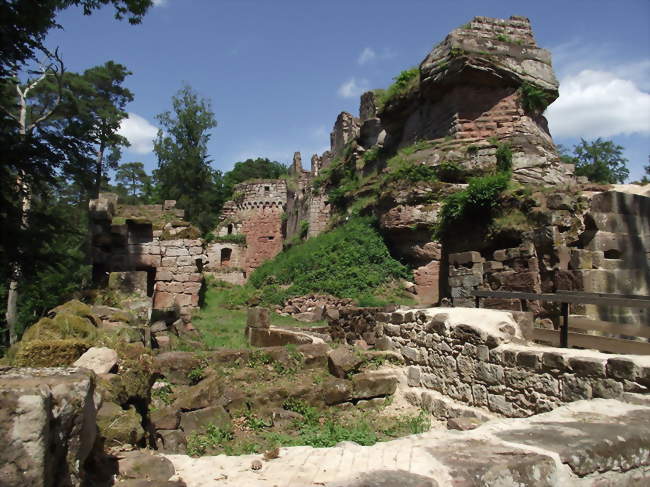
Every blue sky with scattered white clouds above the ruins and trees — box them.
[48,0,650,179]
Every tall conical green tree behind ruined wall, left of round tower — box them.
[153,85,220,232]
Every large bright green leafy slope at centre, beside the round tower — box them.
[249,218,406,297]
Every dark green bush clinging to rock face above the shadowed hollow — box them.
[435,172,510,238]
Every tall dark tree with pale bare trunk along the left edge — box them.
[0,0,152,341]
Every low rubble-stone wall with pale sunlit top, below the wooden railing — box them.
[335,308,650,417]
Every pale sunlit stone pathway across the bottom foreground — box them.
[166,399,650,487]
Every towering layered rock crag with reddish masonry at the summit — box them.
[382,16,572,184]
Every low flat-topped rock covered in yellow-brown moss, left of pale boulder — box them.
[14,338,91,367]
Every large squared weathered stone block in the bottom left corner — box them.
[0,367,97,487]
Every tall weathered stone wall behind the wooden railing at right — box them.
[448,191,650,324]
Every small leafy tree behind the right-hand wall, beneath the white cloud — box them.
[571,137,630,184]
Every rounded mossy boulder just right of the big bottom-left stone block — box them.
[97,402,144,446]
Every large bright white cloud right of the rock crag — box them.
[546,68,650,138]
